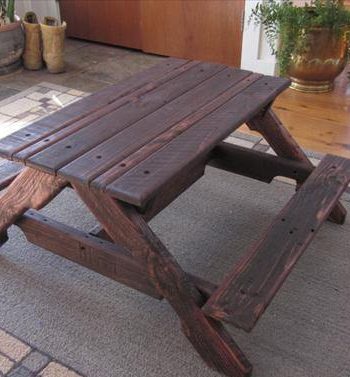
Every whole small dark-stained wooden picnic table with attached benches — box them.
[0,58,350,377]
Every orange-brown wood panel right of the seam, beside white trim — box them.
[141,0,245,67]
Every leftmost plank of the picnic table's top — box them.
[0,58,189,159]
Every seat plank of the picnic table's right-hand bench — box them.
[203,155,350,331]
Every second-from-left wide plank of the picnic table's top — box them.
[26,63,225,173]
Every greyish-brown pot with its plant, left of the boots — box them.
[0,0,24,75]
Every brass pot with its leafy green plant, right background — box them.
[251,0,350,92]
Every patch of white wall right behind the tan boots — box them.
[15,0,60,21]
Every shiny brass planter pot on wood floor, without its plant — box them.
[287,28,349,93]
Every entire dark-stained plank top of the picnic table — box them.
[0,58,289,207]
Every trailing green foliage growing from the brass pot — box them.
[250,0,350,75]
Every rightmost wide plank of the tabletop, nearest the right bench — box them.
[106,76,289,207]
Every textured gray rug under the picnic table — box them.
[0,168,350,377]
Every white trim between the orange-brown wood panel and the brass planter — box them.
[241,0,276,75]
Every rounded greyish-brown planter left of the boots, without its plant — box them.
[0,21,24,75]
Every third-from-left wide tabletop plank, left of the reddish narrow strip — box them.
[58,68,252,183]
